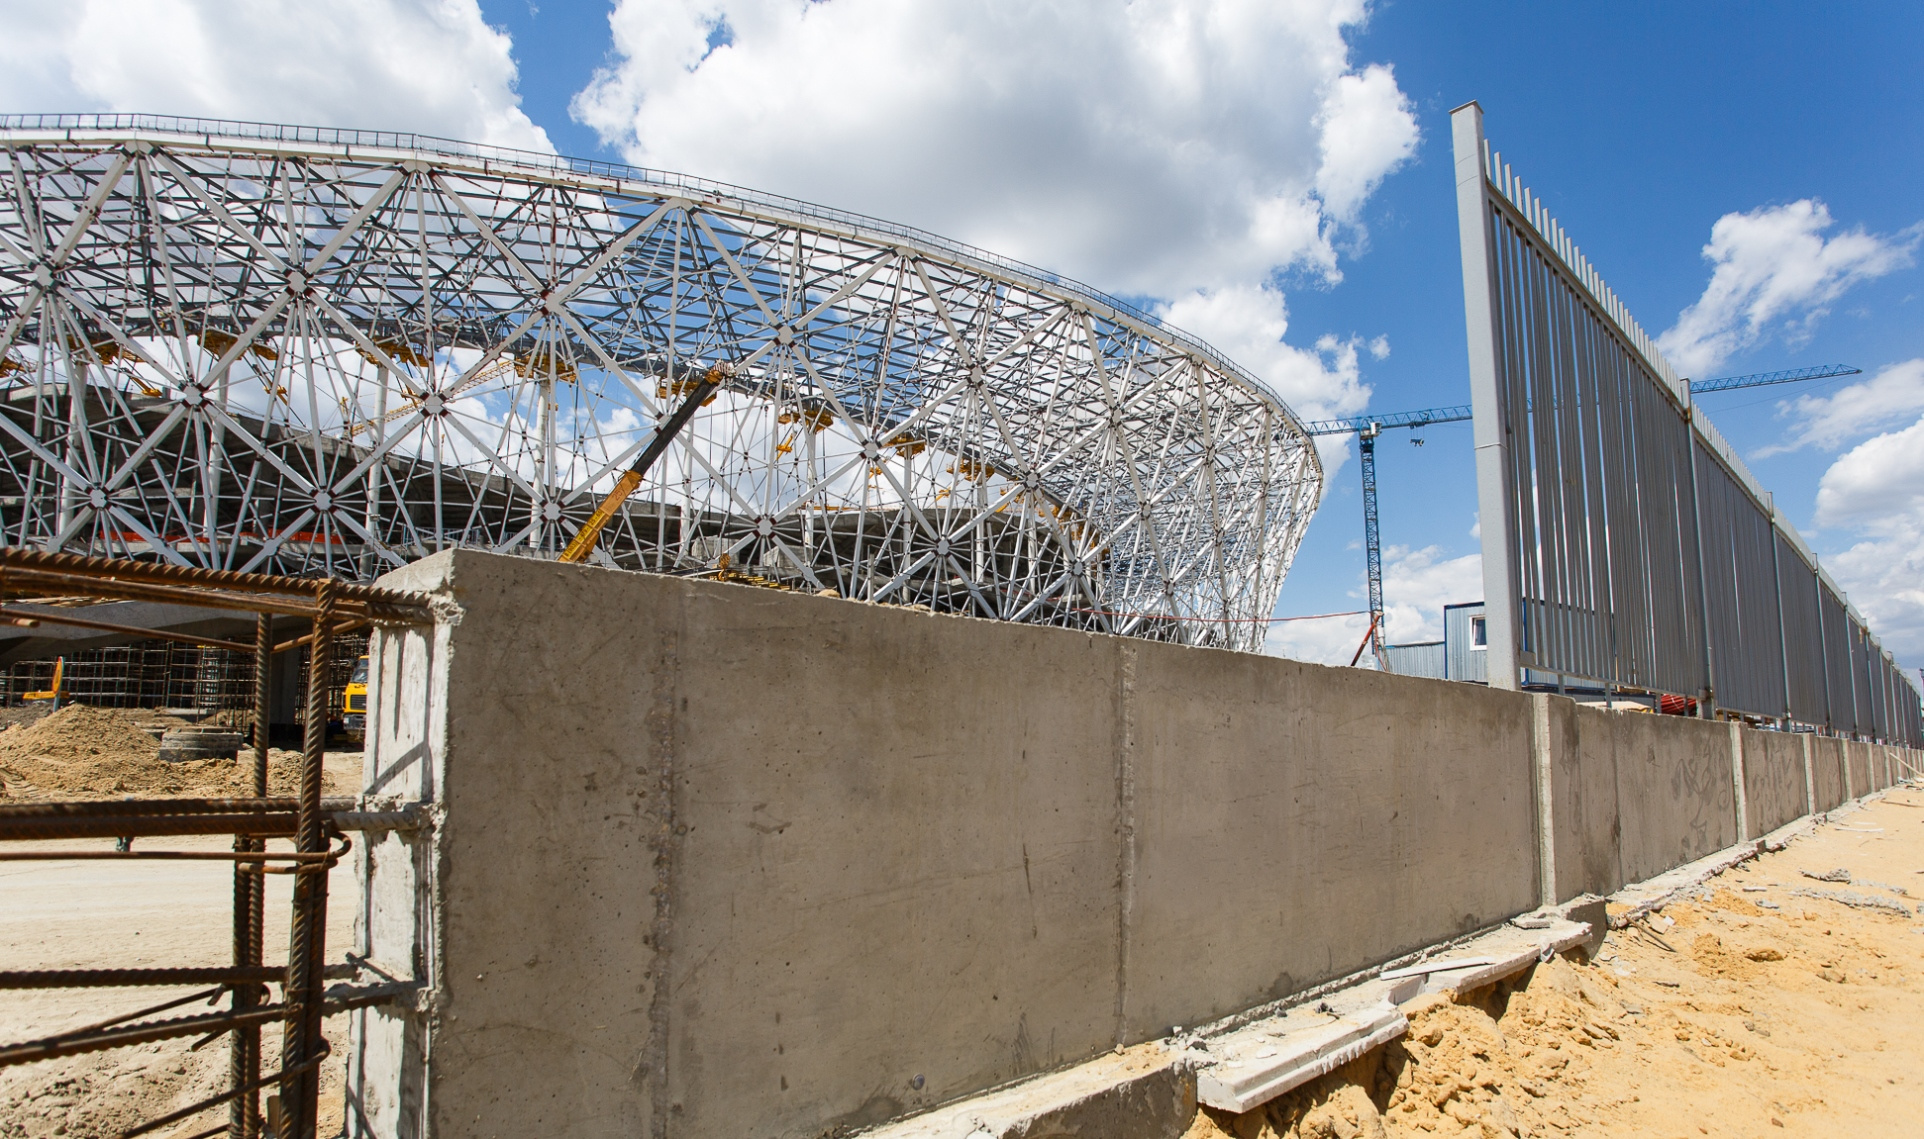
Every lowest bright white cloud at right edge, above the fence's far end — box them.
[1816,411,1924,664]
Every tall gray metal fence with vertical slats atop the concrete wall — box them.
[1453,104,1924,747]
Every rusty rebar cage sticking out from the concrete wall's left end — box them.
[0,548,433,1139]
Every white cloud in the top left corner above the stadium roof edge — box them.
[0,0,552,150]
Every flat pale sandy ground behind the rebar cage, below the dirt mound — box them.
[0,752,360,1139]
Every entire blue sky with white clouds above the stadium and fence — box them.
[0,0,1924,668]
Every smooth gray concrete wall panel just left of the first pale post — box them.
[1120,643,1535,1041]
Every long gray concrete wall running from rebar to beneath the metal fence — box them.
[350,552,1893,1139]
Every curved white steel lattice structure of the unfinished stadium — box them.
[0,115,1322,648]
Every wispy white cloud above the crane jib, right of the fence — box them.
[1657,198,1918,379]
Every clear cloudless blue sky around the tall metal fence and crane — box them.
[1281,2,1924,664]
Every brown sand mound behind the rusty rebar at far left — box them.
[0,704,358,802]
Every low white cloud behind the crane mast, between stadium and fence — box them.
[1262,546,1483,666]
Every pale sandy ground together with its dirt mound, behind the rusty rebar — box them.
[0,708,362,1139]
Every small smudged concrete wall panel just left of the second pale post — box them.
[1612,714,1737,881]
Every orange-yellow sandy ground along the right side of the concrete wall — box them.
[1187,789,1924,1139]
